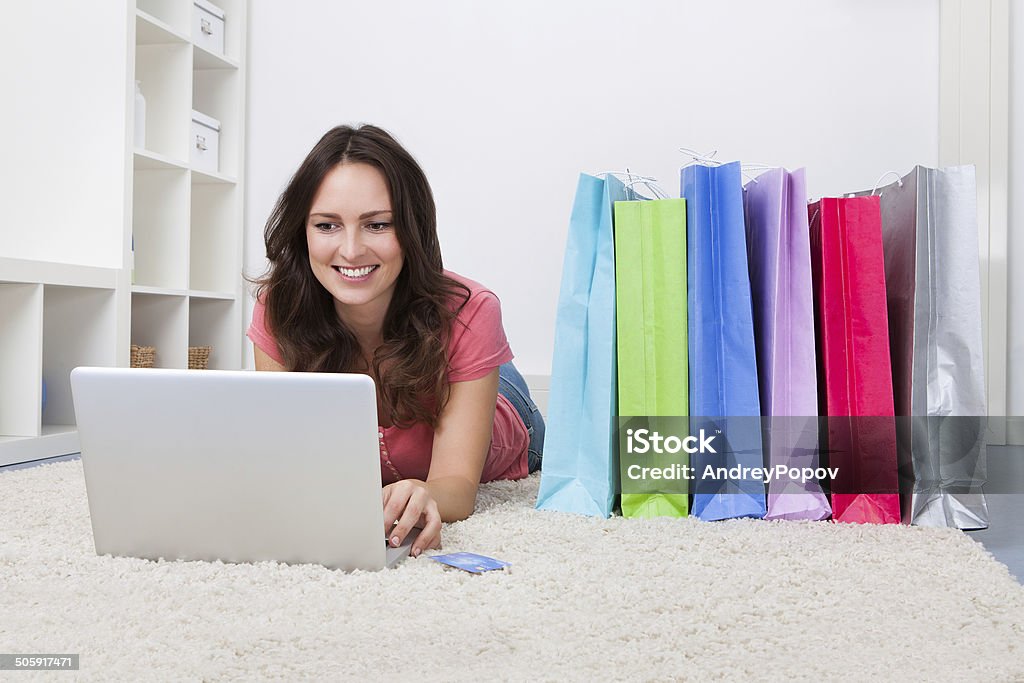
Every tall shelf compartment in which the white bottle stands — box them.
[135,43,191,159]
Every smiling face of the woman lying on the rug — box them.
[306,163,404,325]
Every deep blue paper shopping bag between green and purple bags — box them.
[681,162,766,520]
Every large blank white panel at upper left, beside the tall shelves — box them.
[0,0,126,270]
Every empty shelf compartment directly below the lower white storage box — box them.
[188,176,242,292]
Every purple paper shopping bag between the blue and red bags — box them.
[743,168,831,520]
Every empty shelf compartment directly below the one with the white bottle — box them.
[132,169,190,290]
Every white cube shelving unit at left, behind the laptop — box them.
[0,0,248,466]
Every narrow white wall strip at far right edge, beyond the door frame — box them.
[1007,2,1024,432]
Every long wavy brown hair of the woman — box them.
[254,125,469,428]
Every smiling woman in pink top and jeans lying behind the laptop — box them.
[248,126,544,556]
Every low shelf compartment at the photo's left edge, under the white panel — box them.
[0,284,43,436]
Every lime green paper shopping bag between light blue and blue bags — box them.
[615,194,689,517]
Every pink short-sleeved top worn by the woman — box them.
[247,270,529,484]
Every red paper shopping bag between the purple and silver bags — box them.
[808,197,900,523]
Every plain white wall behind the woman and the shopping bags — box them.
[246,0,939,375]
